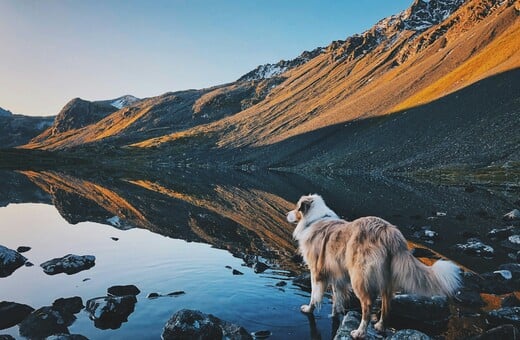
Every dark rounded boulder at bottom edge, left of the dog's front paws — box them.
[162,309,252,340]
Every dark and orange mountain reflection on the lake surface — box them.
[0,170,518,339]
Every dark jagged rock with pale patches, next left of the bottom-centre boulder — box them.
[86,295,137,329]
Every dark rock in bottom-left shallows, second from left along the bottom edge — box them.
[19,306,76,339]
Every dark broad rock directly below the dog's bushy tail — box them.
[390,294,450,332]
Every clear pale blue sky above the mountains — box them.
[0,0,412,115]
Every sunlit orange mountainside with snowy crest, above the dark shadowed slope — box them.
[17,0,520,175]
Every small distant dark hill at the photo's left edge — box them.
[0,107,54,148]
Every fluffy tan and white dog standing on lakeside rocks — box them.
[287,194,461,339]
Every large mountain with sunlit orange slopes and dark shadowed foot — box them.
[20,0,520,172]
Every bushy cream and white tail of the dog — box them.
[391,249,461,296]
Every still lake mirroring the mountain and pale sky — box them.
[0,170,520,339]
